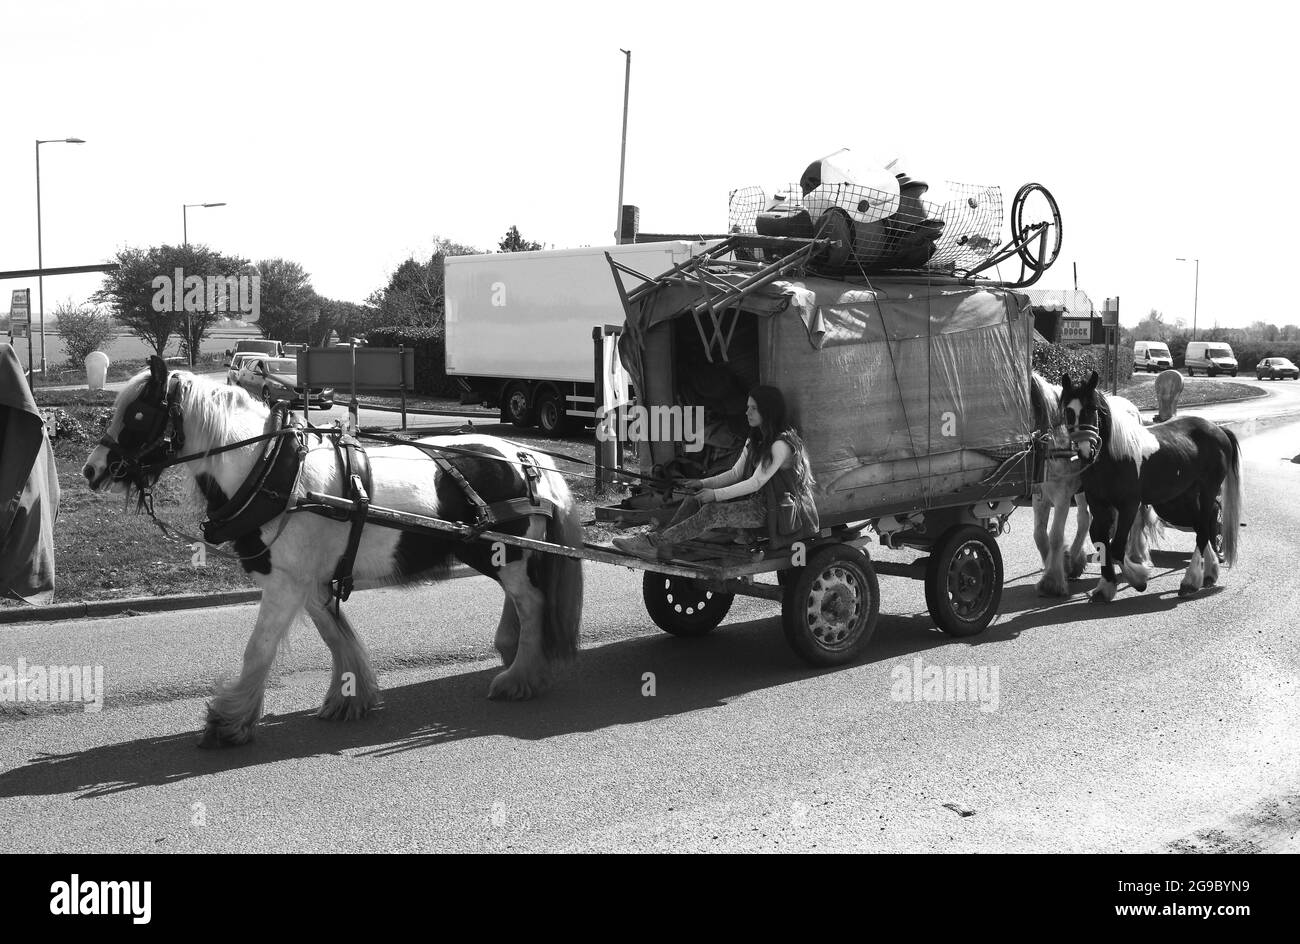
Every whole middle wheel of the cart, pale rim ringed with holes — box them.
[781,544,880,666]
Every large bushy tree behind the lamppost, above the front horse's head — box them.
[91,244,248,356]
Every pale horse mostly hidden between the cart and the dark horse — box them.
[1030,373,1160,597]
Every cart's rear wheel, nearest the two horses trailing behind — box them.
[926,524,1002,636]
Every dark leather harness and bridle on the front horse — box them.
[100,376,555,606]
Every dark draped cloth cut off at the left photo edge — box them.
[0,343,59,605]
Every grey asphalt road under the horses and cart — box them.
[0,384,1300,852]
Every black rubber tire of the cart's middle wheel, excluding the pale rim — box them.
[781,544,880,667]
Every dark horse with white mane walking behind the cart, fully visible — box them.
[1061,371,1242,602]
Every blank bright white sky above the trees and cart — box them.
[0,0,1300,326]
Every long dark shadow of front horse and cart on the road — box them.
[0,615,950,800]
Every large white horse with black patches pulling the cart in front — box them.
[82,358,582,746]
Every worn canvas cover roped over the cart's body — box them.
[620,274,1032,519]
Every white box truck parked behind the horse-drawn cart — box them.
[443,241,714,433]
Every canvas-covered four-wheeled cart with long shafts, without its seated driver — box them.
[295,191,1060,666]
